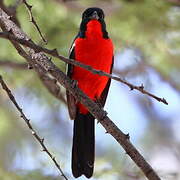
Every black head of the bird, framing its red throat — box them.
[79,7,109,39]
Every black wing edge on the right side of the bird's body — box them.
[98,56,114,107]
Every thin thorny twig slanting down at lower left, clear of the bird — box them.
[0,75,68,180]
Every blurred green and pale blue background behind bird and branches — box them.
[0,0,180,180]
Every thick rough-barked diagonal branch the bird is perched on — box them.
[0,9,160,180]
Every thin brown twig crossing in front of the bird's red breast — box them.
[0,32,168,105]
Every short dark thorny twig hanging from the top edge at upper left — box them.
[23,0,47,43]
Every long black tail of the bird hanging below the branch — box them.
[72,112,95,178]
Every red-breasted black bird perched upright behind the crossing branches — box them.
[66,7,114,178]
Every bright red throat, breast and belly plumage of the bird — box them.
[72,20,113,114]
